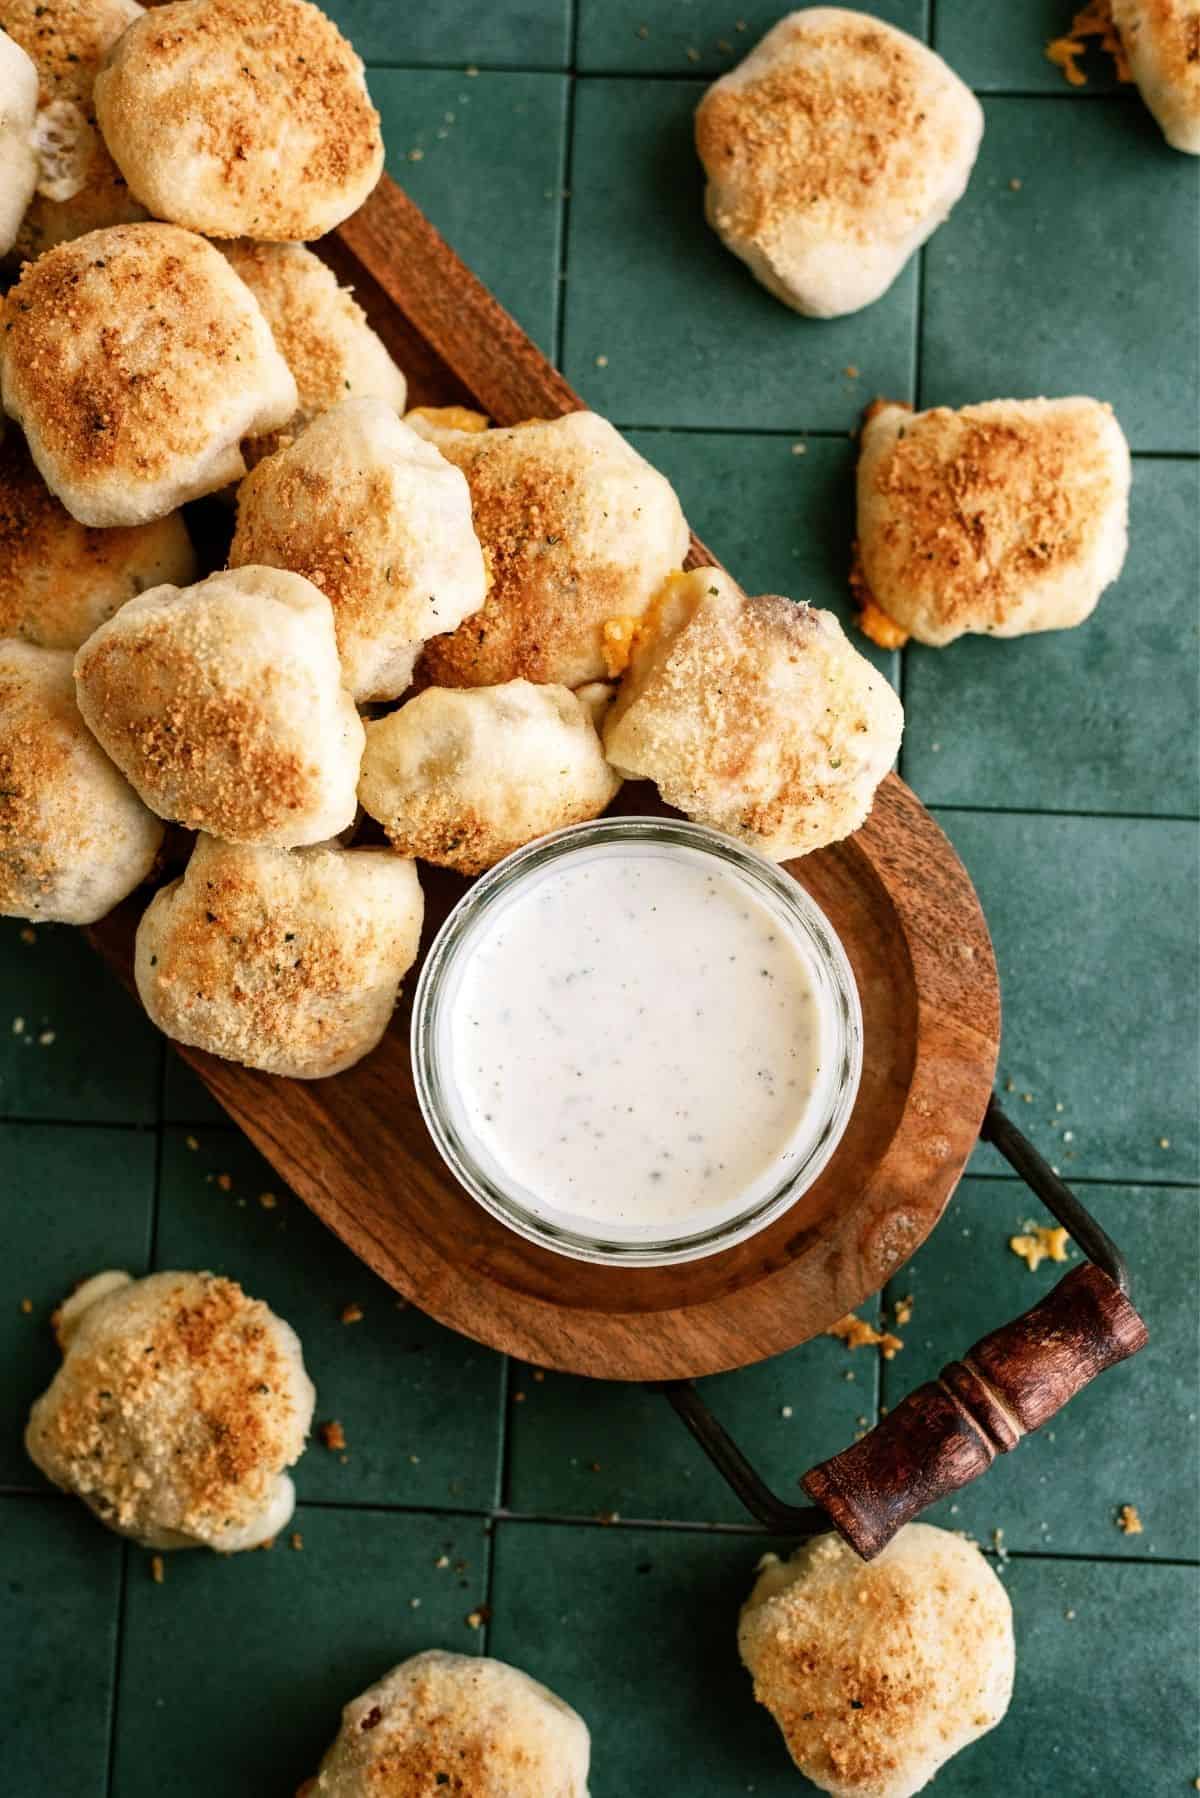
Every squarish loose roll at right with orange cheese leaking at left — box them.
[858,399,1130,645]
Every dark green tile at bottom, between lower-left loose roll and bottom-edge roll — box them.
[109,1507,488,1798]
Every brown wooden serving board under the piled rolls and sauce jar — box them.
[92,180,1000,1381]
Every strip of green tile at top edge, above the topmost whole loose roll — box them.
[576,0,928,76]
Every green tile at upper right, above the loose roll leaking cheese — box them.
[921,97,1200,455]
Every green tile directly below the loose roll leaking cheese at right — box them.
[901,458,1200,818]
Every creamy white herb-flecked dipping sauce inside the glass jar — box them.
[446,843,833,1235]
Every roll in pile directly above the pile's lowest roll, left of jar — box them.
[76,568,363,847]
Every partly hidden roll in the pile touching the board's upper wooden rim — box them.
[218,237,407,466]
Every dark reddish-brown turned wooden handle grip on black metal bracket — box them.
[801,1262,1146,1561]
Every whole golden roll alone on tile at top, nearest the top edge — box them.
[696,5,984,318]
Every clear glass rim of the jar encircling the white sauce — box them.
[412,816,862,1268]
